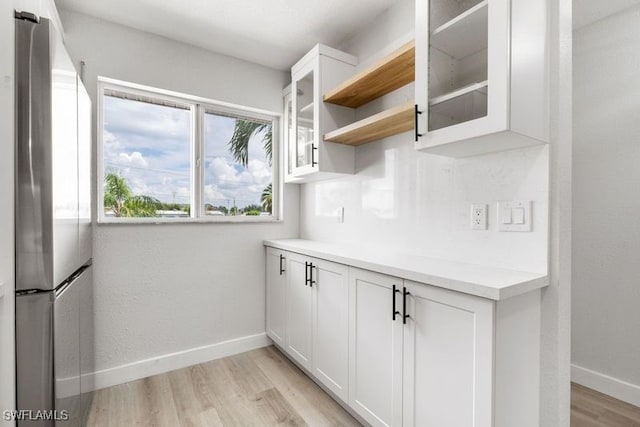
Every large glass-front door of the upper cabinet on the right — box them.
[415,0,511,149]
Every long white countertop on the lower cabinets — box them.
[264,239,549,300]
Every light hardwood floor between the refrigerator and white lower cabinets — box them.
[88,346,360,427]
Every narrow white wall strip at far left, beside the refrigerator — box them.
[0,1,15,426]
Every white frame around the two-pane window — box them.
[96,76,284,224]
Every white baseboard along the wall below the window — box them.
[86,333,272,390]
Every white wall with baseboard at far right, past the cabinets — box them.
[572,6,640,405]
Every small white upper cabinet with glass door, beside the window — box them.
[285,44,357,182]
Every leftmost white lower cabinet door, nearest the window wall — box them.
[267,248,287,347]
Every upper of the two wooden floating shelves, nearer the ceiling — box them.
[324,40,415,108]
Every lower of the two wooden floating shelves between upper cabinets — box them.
[324,101,415,145]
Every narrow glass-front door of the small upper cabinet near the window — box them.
[292,67,318,175]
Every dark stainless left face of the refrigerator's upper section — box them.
[15,15,54,291]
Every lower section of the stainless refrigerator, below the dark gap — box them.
[16,266,89,427]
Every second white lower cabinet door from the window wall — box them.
[285,253,313,371]
